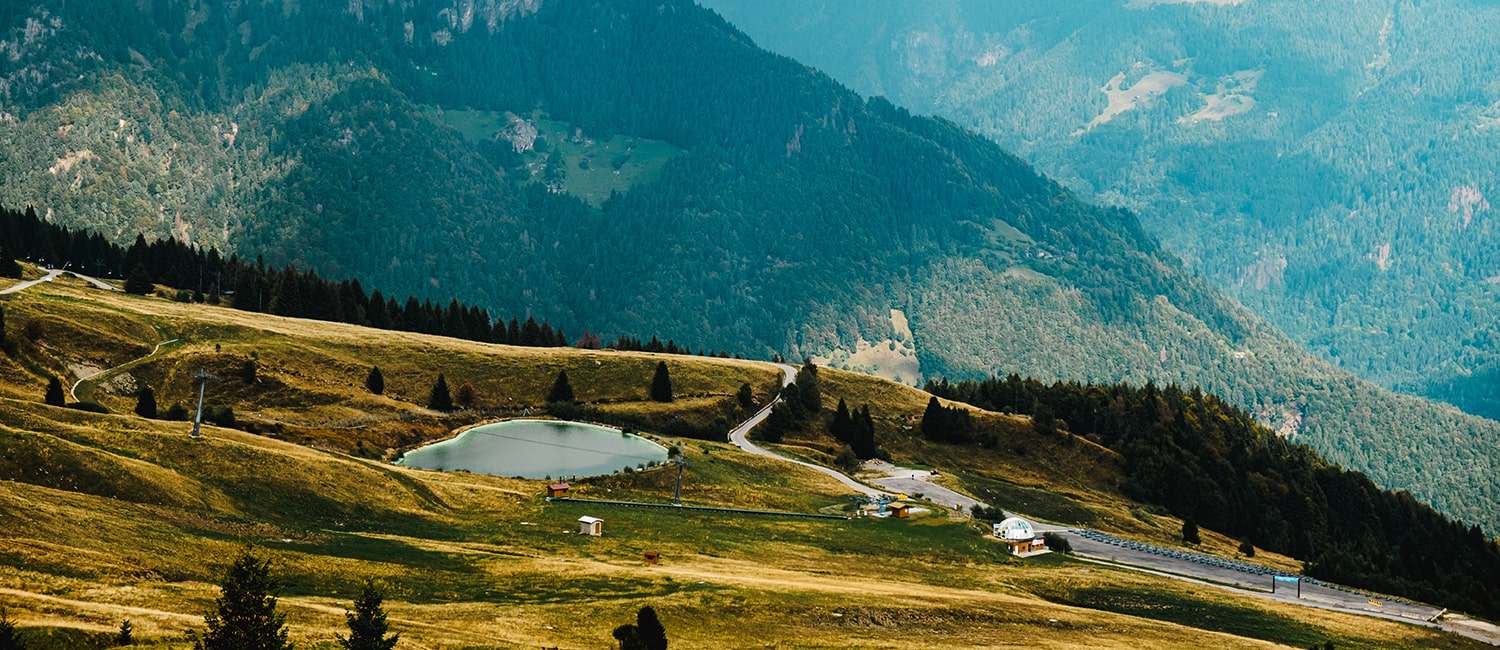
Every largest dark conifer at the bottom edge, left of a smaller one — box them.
[194,551,291,650]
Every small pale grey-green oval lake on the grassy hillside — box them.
[399,420,666,479]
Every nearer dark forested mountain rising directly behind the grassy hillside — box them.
[0,0,1500,530]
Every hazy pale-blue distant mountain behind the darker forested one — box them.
[707,0,1500,417]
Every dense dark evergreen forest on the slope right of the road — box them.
[924,374,1500,617]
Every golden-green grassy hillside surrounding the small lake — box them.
[0,279,1481,648]
